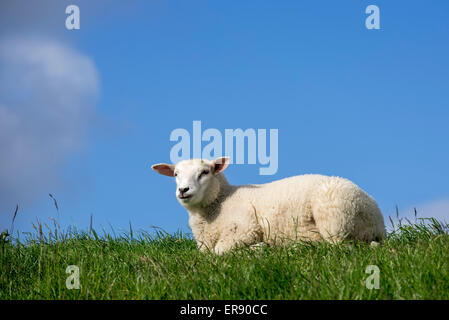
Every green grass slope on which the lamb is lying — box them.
[0,220,449,299]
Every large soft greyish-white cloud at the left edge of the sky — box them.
[0,38,99,214]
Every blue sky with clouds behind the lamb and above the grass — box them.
[0,0,449,238]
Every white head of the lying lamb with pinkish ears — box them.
[151,157,229,208]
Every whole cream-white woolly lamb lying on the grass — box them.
[152,157,386,254]
